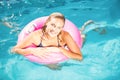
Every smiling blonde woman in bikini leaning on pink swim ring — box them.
[12,13,93,60]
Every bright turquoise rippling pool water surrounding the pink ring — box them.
[0,0,120,80]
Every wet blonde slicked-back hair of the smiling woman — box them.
[42,12,65,32]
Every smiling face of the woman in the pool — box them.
[46,18,64,37]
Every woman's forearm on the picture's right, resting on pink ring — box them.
[60,48,82,60]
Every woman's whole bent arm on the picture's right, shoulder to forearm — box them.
[60,32,82,60]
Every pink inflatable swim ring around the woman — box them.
[18,16,82,64]
